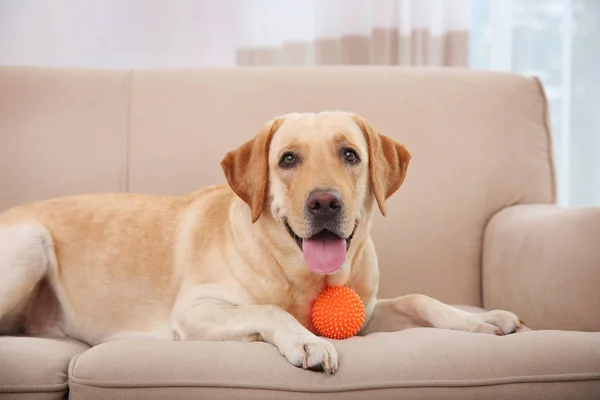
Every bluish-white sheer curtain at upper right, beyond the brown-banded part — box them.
[470,0,600,206]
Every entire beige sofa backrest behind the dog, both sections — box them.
[0,67,555,305]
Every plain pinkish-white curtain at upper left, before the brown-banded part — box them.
[0,0,237,68]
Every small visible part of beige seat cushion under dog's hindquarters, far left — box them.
[0,336,88,399]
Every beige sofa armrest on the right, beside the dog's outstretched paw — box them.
[482,204,600,331]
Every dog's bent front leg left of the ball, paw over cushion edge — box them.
[172,295,338,373]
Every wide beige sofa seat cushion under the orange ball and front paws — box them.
[69,328,600,400]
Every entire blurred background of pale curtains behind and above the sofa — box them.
[0,0,600,206]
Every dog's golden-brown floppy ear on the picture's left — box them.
[221,119,281,223]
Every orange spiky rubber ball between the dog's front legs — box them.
[310,286,365,339]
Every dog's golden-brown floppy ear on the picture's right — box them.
[352,115,411,215]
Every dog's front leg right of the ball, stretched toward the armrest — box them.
[360,294,523,335]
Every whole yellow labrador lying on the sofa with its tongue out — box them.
[0,112,522,373]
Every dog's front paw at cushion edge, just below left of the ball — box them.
[278,334,338,374]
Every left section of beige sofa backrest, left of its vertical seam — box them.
[0,67,129,206]
